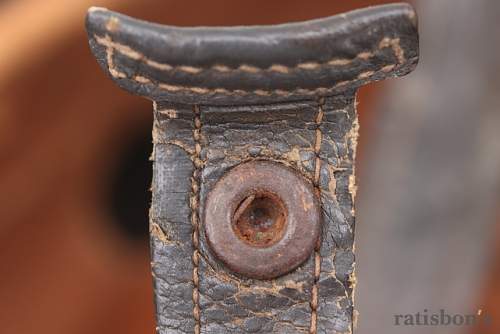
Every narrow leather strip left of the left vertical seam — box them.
[150,104,195,334]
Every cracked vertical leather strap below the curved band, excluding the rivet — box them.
[151,95,357,333]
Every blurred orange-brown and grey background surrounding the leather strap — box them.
[0,0,500,334]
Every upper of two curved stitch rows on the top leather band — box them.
[94,34,405,74]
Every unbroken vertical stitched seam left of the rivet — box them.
[189,105,203,334]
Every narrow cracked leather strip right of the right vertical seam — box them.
[317,92,358,333]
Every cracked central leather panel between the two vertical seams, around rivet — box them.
[199,101,317,334]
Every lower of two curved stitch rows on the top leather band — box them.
[96,35,410,96]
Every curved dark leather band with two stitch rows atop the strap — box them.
[87,4,418,104]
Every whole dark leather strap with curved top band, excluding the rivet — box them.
[87,4,418,334]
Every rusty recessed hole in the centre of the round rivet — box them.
[233,192,287,247]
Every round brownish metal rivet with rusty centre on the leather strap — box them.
[204,160,321,279]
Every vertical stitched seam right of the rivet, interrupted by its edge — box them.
[309,98,325,334]
